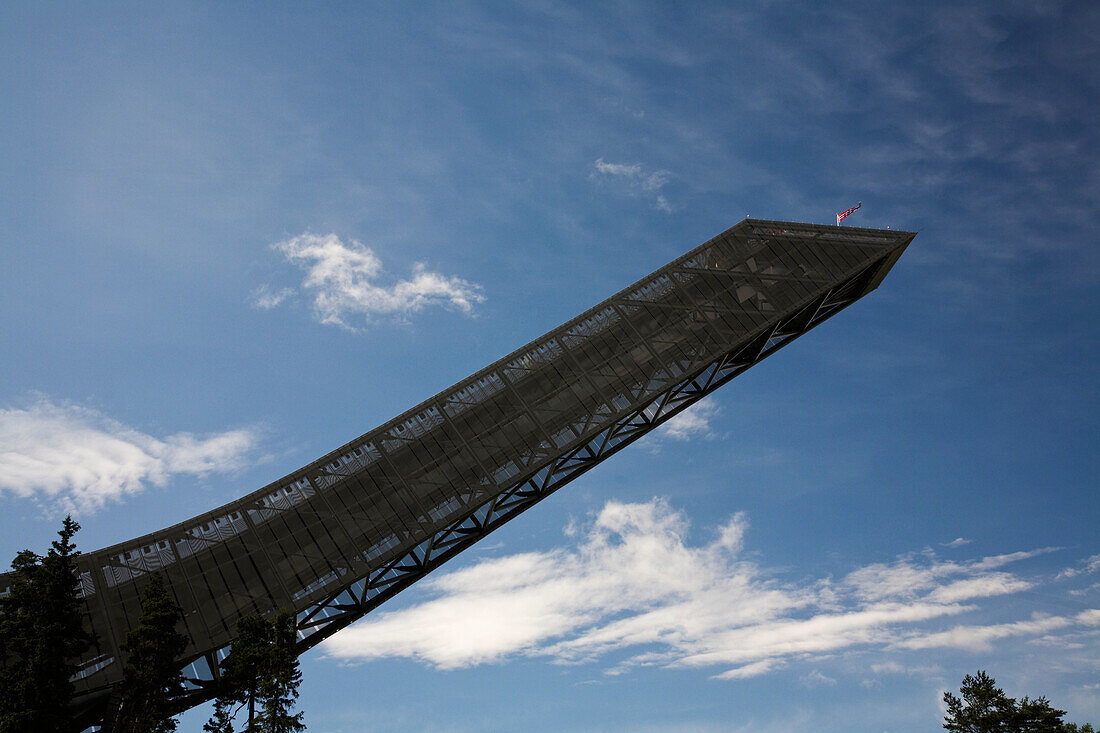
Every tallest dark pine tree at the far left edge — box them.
[0,516,94,733]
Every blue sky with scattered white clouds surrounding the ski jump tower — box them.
[0,2,1100,732]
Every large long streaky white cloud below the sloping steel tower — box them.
[325,500,1092,682]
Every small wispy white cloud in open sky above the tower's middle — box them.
[253,233,485,329]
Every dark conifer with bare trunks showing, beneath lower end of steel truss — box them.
[202,610,306,733]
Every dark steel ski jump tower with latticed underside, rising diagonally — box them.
[0,219,915,722]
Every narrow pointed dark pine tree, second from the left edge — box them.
[112,572,188,733]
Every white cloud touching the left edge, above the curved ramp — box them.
[0,398,256,513]
